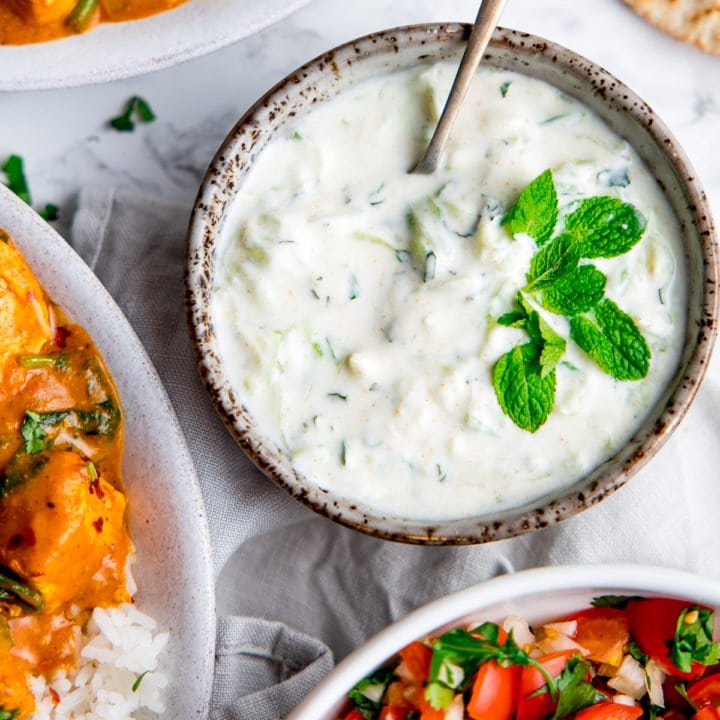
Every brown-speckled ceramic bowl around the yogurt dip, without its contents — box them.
[185,23,718,545]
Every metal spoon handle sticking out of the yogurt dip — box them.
[412,0,507,175]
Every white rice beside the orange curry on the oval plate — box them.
[30,603,168,720]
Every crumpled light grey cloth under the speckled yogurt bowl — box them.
[72,188,720,720]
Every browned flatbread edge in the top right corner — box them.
[625,0,720,54]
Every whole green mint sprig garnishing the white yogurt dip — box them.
[492,170,650,432]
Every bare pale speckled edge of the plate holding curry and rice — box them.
[0,185,215,720]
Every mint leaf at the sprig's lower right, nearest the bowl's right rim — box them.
[570,299,650,380]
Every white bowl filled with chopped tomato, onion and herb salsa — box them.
[288,565,720,720]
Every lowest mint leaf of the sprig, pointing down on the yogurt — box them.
[492,342,555,432]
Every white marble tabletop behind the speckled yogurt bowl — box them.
[0,0,720,235]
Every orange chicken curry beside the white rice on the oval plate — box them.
[0,230,131,720]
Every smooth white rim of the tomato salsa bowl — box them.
[287,563,720,720]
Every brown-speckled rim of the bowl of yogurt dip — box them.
[184,23,719,545]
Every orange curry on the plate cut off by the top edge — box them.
[0,0,185,45]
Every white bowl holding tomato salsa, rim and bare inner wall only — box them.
[287,565,720,720]
